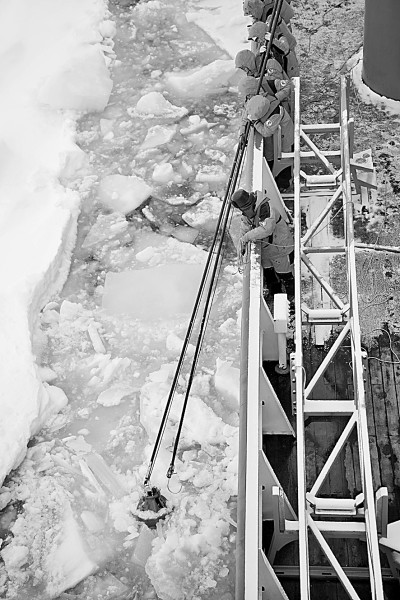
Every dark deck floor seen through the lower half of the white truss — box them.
[264,336,400,600]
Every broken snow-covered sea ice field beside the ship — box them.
[0,0,247,600]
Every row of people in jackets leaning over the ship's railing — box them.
[231,0,299,300]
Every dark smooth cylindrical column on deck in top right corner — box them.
[362,0,400,100]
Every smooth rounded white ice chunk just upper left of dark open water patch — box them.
[98,174,153,214]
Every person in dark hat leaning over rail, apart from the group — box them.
[231,188,294,298]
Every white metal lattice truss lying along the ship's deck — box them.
[291,77,385,600]
